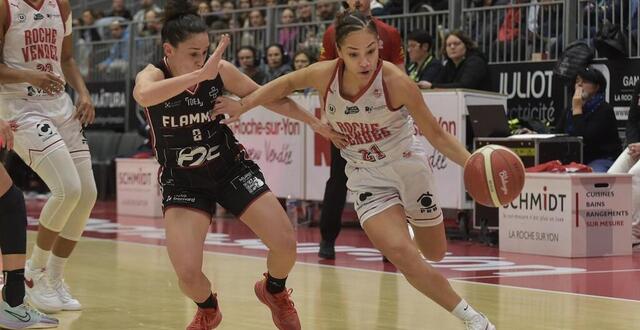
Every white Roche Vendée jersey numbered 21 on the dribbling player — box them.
[324,60,415,167]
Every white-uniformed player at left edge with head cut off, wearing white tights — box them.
[0,0,96,312]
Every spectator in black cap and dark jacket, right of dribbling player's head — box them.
[407,30,442,87]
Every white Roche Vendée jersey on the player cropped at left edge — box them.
[0,0,66,100]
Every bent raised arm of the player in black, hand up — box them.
[133,35,229,107]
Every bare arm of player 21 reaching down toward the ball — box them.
[383,62,471,166]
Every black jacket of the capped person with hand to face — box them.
[556,102,622,164]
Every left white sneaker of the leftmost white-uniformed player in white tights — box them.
[24,260,62,313]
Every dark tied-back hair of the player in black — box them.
[161,0,207,47]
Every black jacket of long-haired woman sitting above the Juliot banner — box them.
[432,50,494,91]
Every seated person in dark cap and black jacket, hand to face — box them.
[556,68,622,172]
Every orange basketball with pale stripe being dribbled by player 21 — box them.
[464,144,524,207]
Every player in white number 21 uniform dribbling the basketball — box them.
[214,5,495,330]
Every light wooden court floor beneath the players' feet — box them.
[37,234,640,330]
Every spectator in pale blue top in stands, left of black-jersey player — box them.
[98,21,129,76]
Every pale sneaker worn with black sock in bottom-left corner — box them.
[0,301,58,329]
